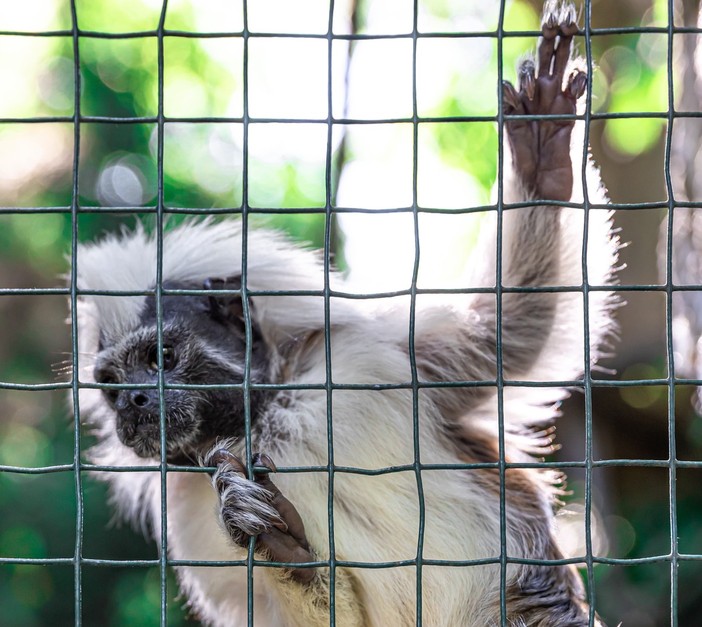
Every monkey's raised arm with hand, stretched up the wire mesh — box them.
[415,6,616,422]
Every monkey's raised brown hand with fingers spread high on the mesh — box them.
[502,0,587,201]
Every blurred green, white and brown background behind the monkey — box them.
[0,0,702,627]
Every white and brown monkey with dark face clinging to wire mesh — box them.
[75,0,618,627]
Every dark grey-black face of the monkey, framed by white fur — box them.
[95,280,268,462]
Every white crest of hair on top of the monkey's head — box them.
[77,218,344,340]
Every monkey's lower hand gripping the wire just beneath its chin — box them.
[204,448,316,583]
